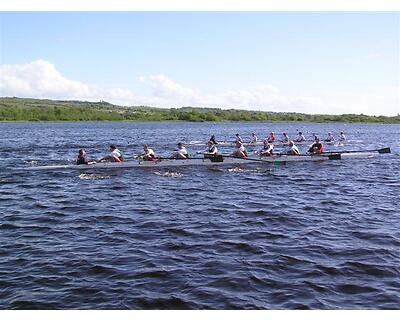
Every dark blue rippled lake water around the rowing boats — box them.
[0,123,400,309]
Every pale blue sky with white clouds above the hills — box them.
[0,12,400,115]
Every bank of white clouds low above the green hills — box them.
[0,60,400,115]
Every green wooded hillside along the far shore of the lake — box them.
[0,97,400,123]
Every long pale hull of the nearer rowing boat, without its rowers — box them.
[17,148,390,171]
